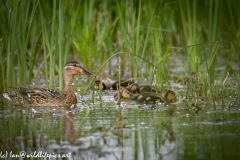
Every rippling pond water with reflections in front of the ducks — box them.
[0,86,240,160]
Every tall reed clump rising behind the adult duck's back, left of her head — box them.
[39,1,79,90]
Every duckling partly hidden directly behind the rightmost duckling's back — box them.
[128,83,159,94]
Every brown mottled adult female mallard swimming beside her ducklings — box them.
[3,61,94,107]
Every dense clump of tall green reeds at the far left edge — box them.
[0,1,39,90]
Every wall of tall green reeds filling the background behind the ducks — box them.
[0,0,240,106]
